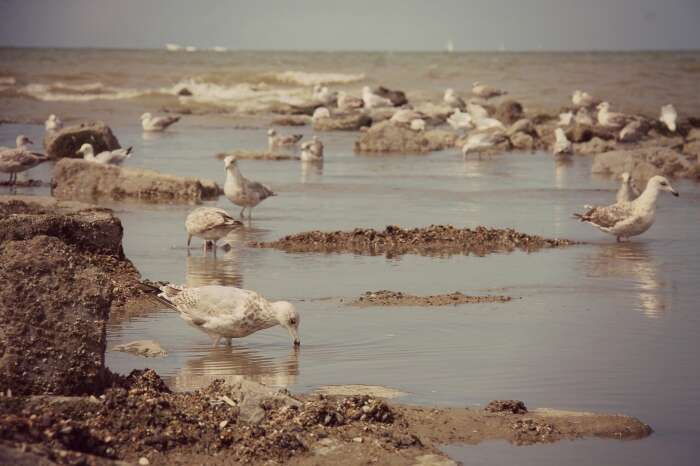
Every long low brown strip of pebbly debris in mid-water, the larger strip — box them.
[251,225,575,256]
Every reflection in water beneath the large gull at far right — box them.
[588,241,668,318]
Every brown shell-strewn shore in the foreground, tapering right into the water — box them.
[0,370,651,465]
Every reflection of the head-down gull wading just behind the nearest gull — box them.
[187,231,244,288]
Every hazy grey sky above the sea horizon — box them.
[0,0,700,50]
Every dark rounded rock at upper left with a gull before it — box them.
[44,121,121,159]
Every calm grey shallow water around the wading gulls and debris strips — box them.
[0,124,700,465]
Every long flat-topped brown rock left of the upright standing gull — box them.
[51,159,222,203]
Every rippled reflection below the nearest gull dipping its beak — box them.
[170,346,300,391]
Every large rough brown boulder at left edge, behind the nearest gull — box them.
[0,197,140,395]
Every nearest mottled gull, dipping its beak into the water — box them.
[158,284,301,347]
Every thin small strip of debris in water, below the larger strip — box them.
[350,290,512,307]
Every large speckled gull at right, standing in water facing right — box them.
[574,175,678,242]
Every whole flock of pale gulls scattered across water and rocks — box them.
[0,82,678,346]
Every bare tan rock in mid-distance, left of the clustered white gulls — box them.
[355,121,456,154]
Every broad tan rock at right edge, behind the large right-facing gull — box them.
[591,147,697,187]
